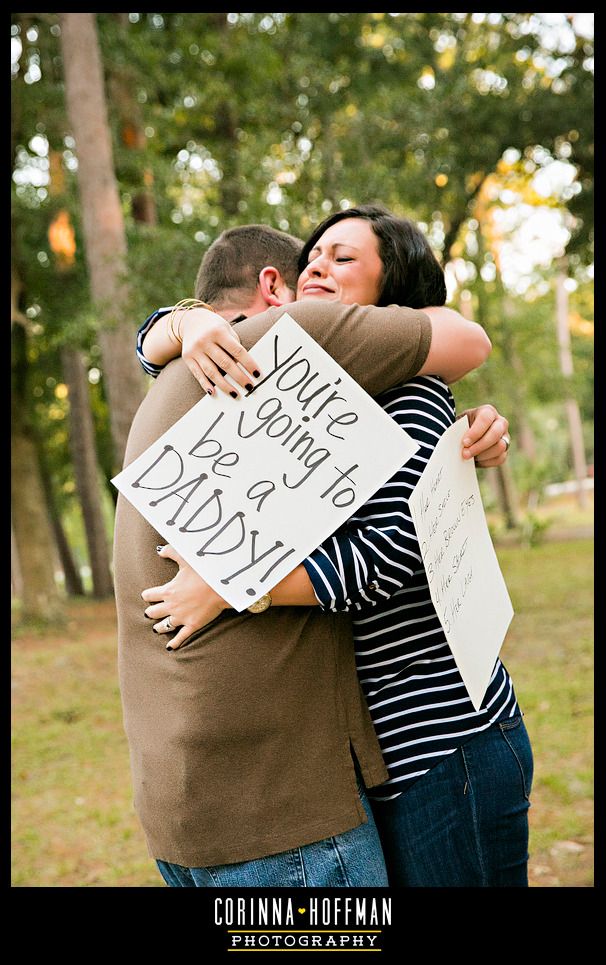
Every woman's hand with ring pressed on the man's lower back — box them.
[141,545,229,650]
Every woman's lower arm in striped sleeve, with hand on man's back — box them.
[141,378,454,650]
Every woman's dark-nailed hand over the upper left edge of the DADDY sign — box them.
[178,308,260,398]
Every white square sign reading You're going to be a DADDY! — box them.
[112,313,418,611]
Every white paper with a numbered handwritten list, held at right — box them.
[409,418,513,710]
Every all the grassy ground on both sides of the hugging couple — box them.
[12,540,593,888]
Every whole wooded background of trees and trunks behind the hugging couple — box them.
[11,12,594,888]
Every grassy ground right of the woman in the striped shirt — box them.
[498,540,593,887]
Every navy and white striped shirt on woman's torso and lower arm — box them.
[304,376,519,799]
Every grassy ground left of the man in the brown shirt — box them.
[13,601,162,887]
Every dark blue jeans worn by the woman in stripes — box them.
[372,715,533,888]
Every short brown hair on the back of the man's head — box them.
[196,224,303,308]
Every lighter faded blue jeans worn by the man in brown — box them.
[156,783,388,888]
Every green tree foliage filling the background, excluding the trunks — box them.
[11,12,593,588]
